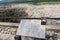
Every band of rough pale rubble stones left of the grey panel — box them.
[0,26,17,35]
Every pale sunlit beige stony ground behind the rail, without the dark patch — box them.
[0,4,60,18]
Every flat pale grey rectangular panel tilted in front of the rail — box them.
[16,19,45,38]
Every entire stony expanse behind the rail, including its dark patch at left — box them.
[0,4,60,22]
